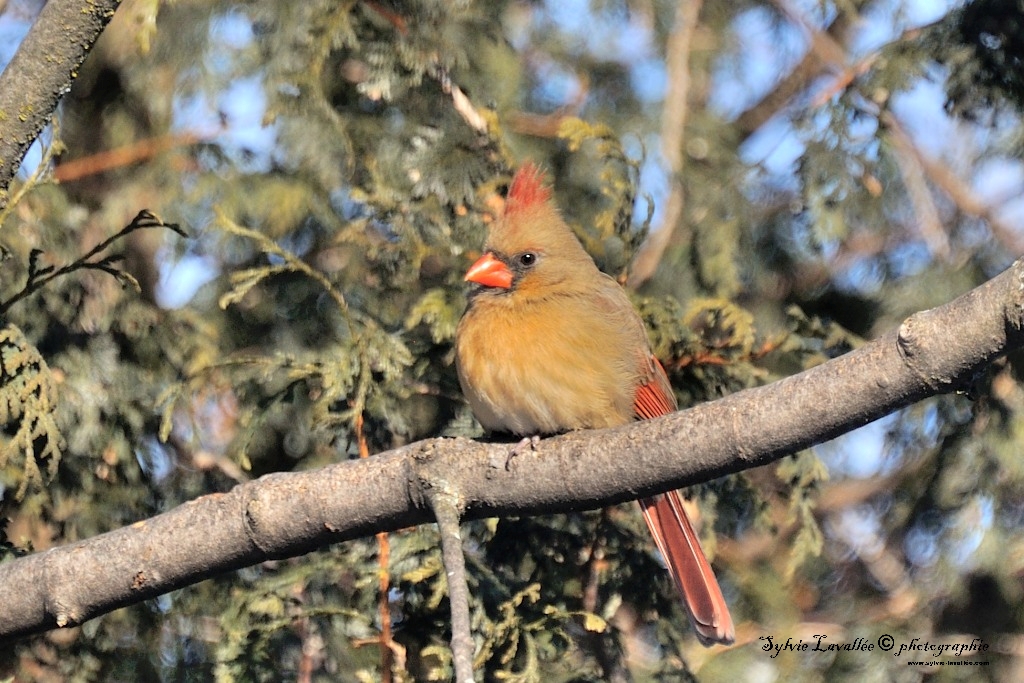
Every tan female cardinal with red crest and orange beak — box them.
[456,164,734,645]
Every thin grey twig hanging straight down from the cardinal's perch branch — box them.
[427,480,473,683]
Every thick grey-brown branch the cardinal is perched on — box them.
[0,261,1024,641]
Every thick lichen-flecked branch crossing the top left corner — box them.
[0,0,121,209]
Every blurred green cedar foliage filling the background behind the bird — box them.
[0,0,1024,682]
